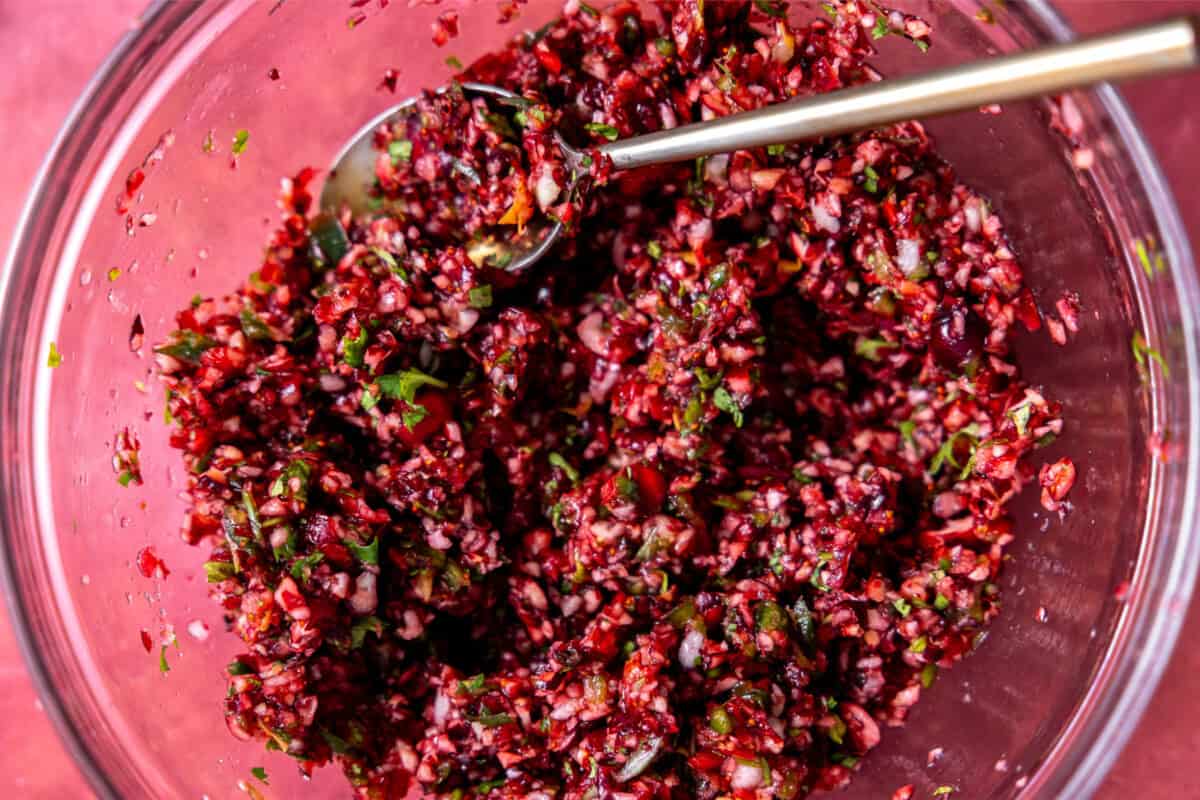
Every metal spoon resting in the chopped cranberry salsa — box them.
[320,17,1200,271]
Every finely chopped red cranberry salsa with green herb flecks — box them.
[154,0,1074,800]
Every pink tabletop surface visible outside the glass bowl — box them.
[0,0,1200,800]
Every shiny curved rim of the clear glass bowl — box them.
[0,0,1200,800]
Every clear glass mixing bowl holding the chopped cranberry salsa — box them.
[0,0,1200,799]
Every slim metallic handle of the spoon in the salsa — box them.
[600,17,1200,169]
